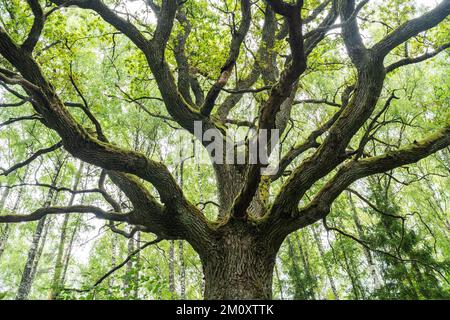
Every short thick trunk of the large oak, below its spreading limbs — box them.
[200,223,278,300]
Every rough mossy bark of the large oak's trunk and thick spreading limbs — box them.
[0,0,450,299]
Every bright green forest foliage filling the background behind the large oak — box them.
[0,0,450,300]
